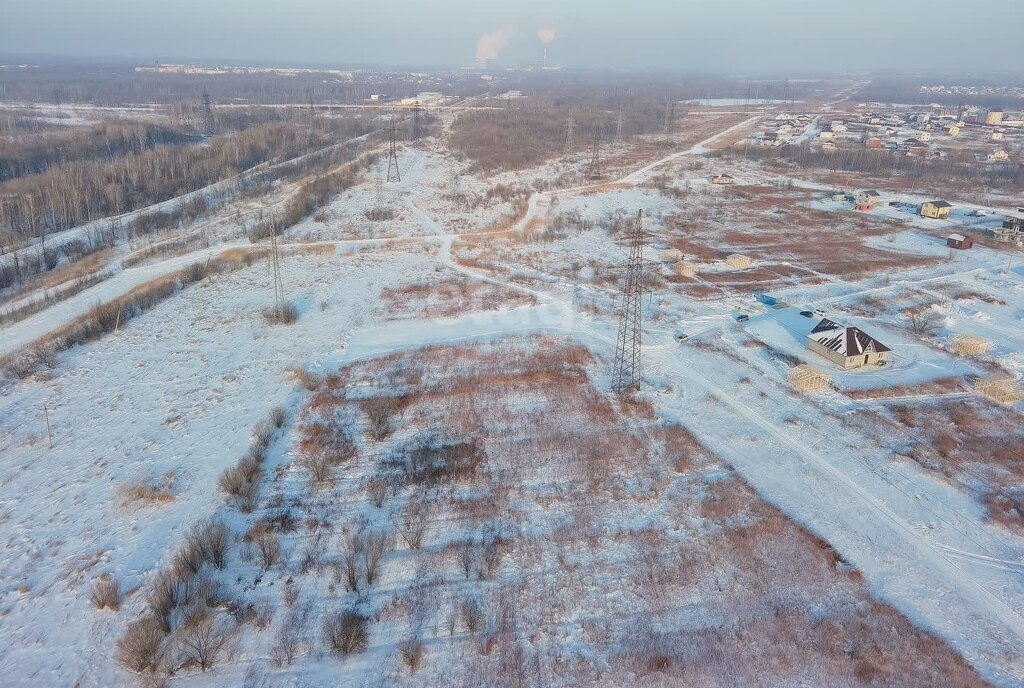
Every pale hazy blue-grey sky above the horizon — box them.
[0,0,1024,71]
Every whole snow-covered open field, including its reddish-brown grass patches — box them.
[0,107,1024,687]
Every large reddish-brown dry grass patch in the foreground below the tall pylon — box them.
[253,336,983,688]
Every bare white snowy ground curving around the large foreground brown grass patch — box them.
[0,110,1024,686]
